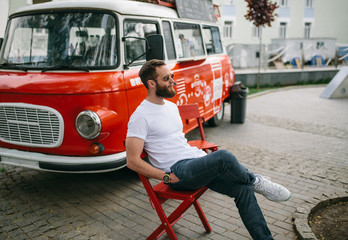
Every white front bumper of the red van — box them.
[0,147,126,173]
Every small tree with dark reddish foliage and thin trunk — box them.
[244,0,278,88]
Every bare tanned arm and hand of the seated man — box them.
[126,137,179,183]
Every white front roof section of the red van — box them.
[14,0,178,18]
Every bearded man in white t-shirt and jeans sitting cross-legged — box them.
[126,60,290,239]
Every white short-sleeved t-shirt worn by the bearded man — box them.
[127,100,206,171]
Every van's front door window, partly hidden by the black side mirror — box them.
[124,20,159,63]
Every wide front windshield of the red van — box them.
[0,12,118,70]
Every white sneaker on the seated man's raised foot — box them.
[254,175,291,202]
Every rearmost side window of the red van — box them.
[203,26,223,55]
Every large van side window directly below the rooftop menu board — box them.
[174,22,204,58]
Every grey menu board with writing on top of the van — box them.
[176,0,216,22]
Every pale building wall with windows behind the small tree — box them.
[219,0,348,45]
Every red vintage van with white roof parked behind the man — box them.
[0,0,234,173]
